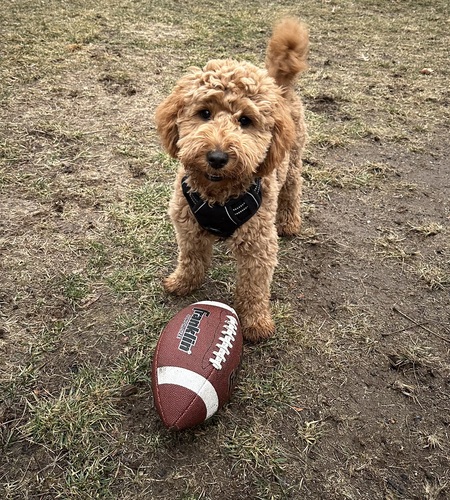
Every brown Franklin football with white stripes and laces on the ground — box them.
[152,301,242,430]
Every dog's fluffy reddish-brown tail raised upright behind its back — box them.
[266,18,309,89]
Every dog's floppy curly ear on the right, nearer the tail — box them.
[257,102,295,177]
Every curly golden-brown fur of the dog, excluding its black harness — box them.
[156,19,308,341]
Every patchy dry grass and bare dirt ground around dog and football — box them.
[0,0,450,500]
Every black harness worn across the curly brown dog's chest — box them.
[181,176,262,238]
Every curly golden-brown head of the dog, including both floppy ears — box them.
[156,60,295,196]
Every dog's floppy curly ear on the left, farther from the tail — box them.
[155,85,184,158]
